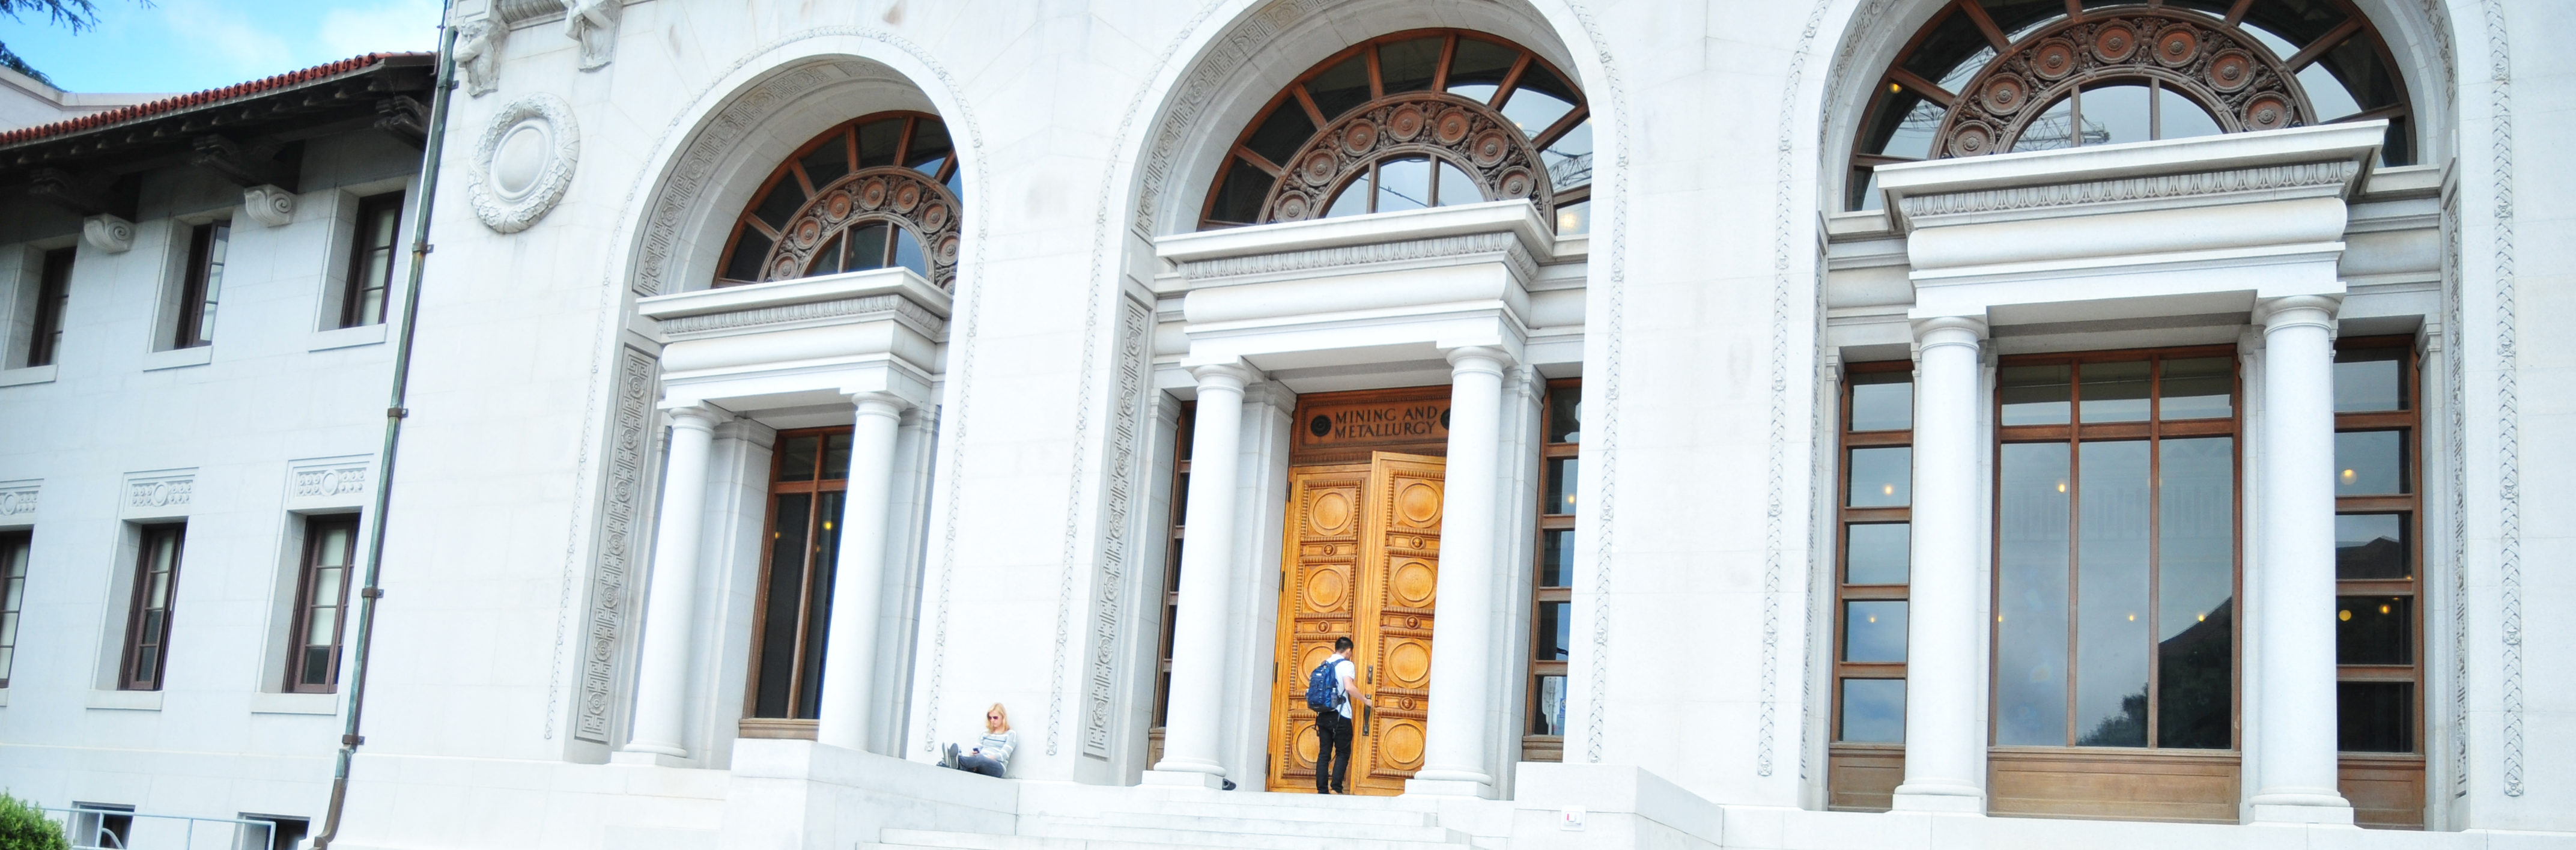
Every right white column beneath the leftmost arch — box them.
[814,392,907,750]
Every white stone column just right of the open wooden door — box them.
[1404,348,1510,796]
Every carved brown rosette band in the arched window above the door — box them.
[1262,93,1556,222]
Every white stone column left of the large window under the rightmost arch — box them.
[1894,317,1988,814]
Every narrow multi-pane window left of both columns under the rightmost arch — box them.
[1826,360,1914,812]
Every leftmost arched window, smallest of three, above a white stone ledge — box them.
[716,114,961,288]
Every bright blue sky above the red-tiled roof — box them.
[0,0,438,93]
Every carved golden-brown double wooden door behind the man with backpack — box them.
[1270,451,1445,794]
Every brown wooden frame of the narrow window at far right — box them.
[2334,335,2458,830]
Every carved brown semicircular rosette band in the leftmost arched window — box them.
[760,165,964,291]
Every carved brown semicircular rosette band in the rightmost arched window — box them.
[1932,10,2316,160]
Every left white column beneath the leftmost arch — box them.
[624,404,718,757]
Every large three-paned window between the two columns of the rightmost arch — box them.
[1994,348,2238,750]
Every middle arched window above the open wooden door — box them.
[1198,31,1592,234]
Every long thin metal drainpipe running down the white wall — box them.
[314,0,456,850]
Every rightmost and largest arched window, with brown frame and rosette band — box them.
[1844,0,2414,208]
